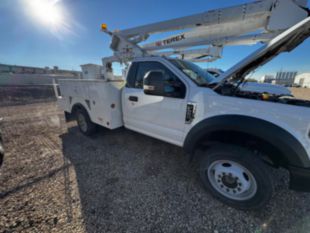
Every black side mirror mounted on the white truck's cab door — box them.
[143,70,165,96]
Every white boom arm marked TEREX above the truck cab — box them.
[104,0,309,62]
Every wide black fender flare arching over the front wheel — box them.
[183,115,310,167]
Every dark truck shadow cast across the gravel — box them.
[61,127,310,233]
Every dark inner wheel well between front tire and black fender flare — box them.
[198,130,288,167]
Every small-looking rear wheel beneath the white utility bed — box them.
[75,109,97,136]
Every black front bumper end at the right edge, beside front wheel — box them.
[289,166,310,192]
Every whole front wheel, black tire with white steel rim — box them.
[199,144,273,210]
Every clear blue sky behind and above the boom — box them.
[0,0,310,77]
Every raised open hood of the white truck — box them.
[214,17,310,86]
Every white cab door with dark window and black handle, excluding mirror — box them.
[123,61,187,145]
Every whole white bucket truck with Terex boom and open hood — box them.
[57,0,310,209]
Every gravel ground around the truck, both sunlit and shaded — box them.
[0,102,310,233]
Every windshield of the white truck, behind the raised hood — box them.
[170,59,216,86]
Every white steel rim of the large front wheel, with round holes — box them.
[207,160,257,201]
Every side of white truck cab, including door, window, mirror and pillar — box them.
[122,57,194,146]
